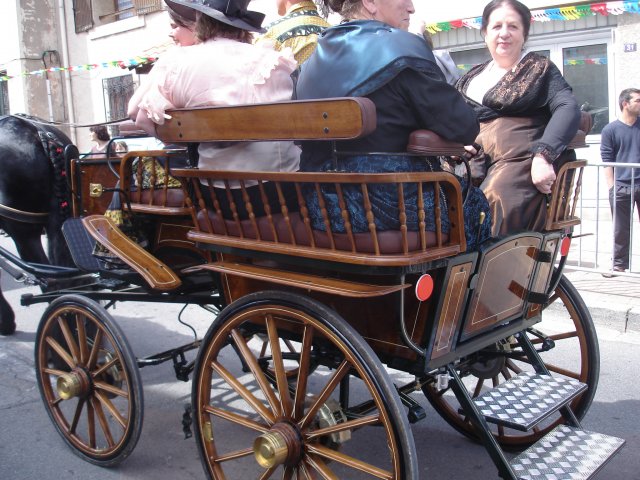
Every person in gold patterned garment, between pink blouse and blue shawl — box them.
[261,0,331,65]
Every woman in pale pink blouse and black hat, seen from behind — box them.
[129,0,300,218]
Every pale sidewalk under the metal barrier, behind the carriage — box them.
[565,267,640,332]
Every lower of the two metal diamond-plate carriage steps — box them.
[509,425,625,480]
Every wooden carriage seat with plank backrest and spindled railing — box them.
[156,98,466,265]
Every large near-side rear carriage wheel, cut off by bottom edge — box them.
[192,292,418,480]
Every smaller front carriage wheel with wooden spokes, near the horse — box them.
[35,295,143,467]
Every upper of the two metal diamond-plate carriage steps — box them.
[473,372,587,432]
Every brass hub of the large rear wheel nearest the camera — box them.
[253,423,303,469]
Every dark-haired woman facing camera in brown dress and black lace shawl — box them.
[456,0,580,235]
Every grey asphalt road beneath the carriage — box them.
[0,264,640,480]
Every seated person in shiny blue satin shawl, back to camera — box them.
[295,0,490,250]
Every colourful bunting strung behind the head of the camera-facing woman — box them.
[425,0,640,35]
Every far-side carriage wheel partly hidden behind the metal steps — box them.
[422,275,600,450]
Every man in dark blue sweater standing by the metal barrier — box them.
[600,88,640,272]
